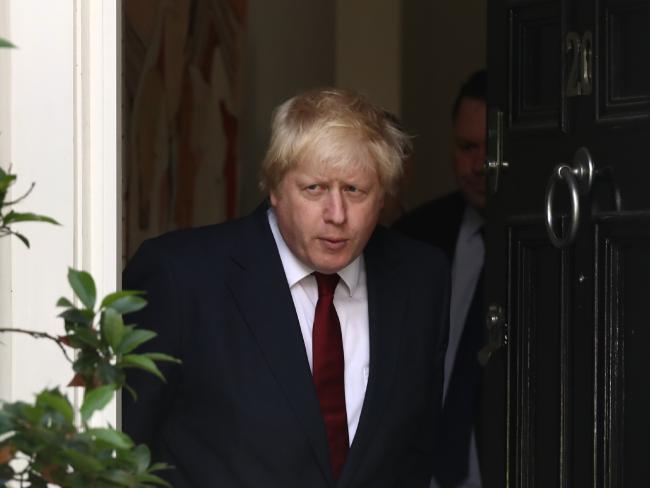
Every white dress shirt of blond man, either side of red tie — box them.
[267,209,370,444]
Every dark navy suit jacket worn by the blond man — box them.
[123,206,449,488]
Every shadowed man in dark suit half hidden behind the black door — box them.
[395,70,486,488]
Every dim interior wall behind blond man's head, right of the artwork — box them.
[132,0,486,215]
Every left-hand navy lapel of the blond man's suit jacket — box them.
[227,207,332,483]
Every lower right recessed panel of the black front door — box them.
[596,212,650,487]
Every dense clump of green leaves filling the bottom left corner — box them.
[0,389,169,488]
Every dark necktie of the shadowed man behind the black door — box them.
[434,232,485,488]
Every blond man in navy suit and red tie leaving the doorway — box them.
[123,89,449,488]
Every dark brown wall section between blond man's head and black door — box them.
[402,0,487,208]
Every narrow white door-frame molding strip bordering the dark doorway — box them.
[83,0,122,425]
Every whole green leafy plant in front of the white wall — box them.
[0,38,179,488]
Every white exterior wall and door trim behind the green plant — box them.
[0,0,120,421]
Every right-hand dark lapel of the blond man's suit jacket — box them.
[337,228,406,487]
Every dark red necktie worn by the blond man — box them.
[312,272,349,479]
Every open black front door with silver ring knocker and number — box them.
[480,0,650,488]
